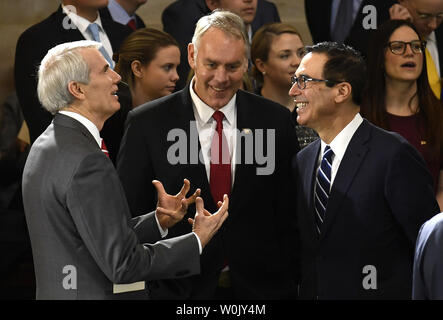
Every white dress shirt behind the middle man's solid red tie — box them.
[189,78,237,187]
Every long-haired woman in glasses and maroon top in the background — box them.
[361,20,443,209]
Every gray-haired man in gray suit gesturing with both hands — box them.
[23,40,228,299]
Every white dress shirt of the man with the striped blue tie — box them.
[317,113,363,188]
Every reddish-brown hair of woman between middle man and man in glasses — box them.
[251,22,303,83]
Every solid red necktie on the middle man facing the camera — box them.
[209,111,231,204]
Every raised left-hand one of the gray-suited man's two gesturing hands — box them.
[152,179,201,229]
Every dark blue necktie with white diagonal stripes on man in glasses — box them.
[314,146,334,234]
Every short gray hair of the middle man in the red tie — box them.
[192,9,250,59]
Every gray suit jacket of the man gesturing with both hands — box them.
[23,114,199,299]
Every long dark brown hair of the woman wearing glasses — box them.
[361,20,443,155]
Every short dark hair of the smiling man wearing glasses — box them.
[306,42,366,105]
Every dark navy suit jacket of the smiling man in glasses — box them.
[293,120,439,299]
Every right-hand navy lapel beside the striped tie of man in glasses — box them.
[320,120,370,239]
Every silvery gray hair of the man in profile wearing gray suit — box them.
[37,40,102,114]
